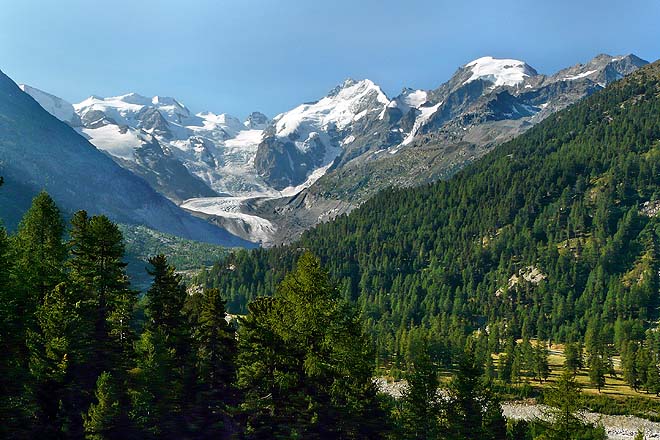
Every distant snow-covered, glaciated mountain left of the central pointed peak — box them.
[69,93,269,202]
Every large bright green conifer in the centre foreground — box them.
[238,254,383,438]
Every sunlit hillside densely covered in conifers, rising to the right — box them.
[200,62,660,372]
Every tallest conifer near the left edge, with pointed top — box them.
[6,192,70,435]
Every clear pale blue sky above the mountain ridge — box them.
[0,0,660,117]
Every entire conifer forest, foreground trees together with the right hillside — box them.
[0,63,660,439]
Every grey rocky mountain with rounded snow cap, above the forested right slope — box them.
[254,55,647,242]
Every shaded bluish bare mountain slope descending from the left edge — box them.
[0,72,251,246]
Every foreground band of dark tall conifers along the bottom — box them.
[0,187,604,439]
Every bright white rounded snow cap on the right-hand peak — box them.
[463,56,538,87]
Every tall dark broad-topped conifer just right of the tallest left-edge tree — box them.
[67,211,136,435]
